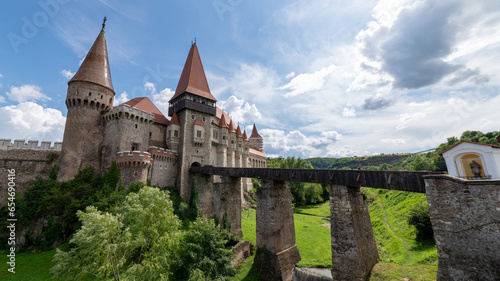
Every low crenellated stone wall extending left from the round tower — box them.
[0,139,61,207]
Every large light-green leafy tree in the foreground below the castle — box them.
[51,186,181,280]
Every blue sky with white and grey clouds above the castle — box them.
[0,0,500,158]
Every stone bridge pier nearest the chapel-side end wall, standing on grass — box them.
[329,185,379,281]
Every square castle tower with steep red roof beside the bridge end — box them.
[168,43,217,201]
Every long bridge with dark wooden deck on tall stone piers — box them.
[190,166,500,280]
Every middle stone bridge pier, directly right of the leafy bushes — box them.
[254,180,300,281]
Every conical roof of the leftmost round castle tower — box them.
[68,18,115,94]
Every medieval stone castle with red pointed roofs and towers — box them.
[0,20,266,200]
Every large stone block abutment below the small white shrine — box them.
[424,175,500,280]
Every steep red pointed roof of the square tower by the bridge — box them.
[170,43,217,101]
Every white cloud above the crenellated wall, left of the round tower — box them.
[0,102,66,141]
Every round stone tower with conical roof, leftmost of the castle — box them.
[58,18,115,181]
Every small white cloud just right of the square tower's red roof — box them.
[218,96,262,124]
